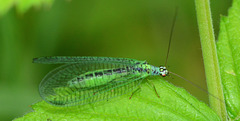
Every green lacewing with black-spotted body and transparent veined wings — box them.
[33,56,168,106]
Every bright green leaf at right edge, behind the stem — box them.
[217,0,240,120]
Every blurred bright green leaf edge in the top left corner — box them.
[0,0,53,16]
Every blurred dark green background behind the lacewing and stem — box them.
[0,0,231,120]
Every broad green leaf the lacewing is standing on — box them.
[16,77,220,121]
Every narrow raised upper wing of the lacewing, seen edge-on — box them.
[33,56,144,64]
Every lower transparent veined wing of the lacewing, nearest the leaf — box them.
[47,74,146,106]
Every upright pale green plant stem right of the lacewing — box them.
[195,0,227,121]
